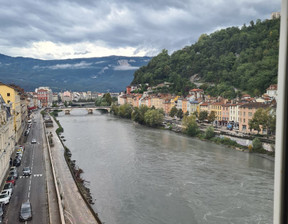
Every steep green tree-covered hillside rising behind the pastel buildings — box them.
[132,19,280,98]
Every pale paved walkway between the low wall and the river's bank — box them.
[46,121,97,224]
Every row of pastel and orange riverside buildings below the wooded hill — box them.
[118,85,277,133]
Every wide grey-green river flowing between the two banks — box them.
[58,109,274,224]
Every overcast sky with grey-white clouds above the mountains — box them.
[0,0,281,60]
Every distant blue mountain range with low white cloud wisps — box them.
[0,54,151,92]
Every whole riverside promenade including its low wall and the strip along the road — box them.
[44,118,98,224]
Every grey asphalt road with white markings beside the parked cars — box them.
[4,112,49,224]
